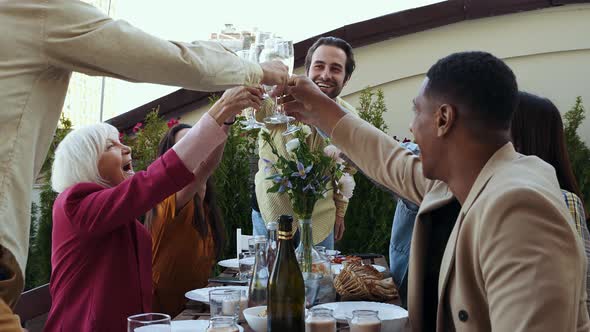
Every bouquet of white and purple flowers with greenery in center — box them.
[262,125,354,219]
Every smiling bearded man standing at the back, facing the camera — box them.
[252,37,356,249]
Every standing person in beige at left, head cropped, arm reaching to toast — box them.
[0,0,287,314]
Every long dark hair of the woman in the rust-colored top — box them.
[145,123,225,258]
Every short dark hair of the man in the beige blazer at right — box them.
[425,52,518,129]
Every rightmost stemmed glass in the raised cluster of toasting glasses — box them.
[259,37,299,136]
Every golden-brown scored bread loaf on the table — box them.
[334,261,399,301]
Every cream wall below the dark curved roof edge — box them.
[182,5,590,143]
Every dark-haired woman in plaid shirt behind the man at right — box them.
[511,91,590,312]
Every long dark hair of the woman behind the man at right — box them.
[511,91,590,218]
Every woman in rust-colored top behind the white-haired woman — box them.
[146,124,228,317]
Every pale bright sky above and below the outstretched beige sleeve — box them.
[107,0,441,113]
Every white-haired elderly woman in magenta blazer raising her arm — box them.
[45,87,262,331]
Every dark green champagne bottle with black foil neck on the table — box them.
[267,215,305,332]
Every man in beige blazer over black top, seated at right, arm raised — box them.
[286,52,590,332]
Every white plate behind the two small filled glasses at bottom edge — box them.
[314,301,408,332]
